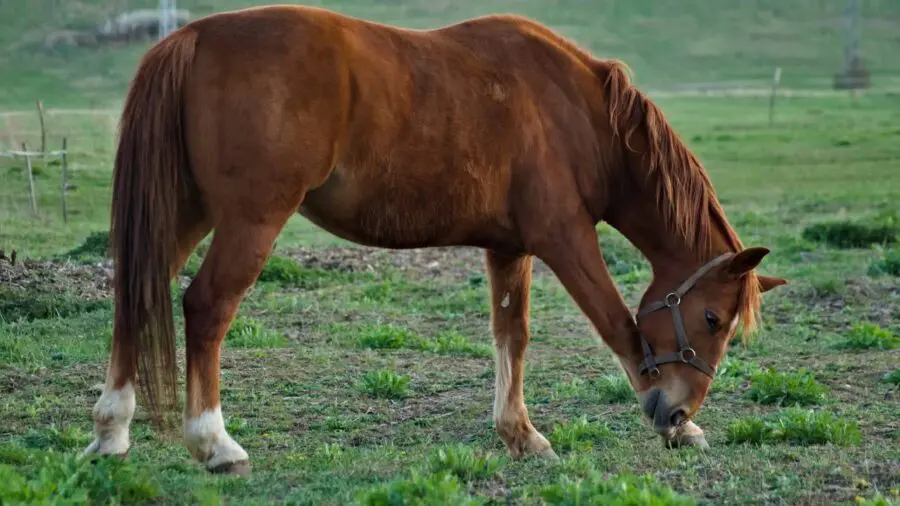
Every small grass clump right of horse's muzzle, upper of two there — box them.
[746,369,828,406]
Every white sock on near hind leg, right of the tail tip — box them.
[184,406,248,469]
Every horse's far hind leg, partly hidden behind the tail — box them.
[84,208,210,457]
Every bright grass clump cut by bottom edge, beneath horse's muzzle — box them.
[540,470,696,506]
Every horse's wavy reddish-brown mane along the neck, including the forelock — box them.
[595,60,761,336]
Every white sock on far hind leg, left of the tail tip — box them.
[84,382,135,455]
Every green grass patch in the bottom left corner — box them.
[0,451,159,505]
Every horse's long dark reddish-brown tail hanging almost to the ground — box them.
[110,28,196,430]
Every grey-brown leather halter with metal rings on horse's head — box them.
[635,253,732,379]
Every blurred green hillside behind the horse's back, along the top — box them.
[0,0,900,109]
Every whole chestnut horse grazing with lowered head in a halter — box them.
[85,6,785,474]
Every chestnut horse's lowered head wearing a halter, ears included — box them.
[631,248,786,440]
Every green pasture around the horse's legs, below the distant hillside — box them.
[0,89,900,505]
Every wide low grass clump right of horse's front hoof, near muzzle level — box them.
[726,408,862,446]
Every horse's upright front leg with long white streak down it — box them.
[486,251,556,458]
